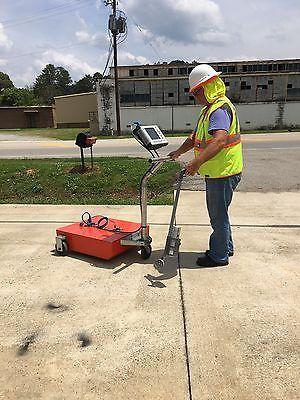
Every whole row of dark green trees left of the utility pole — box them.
[0,64,102,107]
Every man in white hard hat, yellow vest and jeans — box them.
[169,64,243,267]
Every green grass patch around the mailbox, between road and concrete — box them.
[0,157,180,204]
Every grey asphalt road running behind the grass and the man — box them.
[0,132,300,192]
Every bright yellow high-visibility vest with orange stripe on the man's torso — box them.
[194,96,243,178]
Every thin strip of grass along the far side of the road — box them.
[0,128,296,140]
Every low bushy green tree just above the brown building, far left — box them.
[0,87,39,107]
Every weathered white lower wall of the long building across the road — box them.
[97,81,300,133]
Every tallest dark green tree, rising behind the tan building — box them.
[33,64,72,104]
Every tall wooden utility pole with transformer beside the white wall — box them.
[104,0,120,136]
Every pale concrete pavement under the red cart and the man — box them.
[0,192,300,400]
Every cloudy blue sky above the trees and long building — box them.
[0,0,300,87]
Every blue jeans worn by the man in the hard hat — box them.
[205,174,241,262]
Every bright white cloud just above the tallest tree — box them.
[35,50,98,75]
